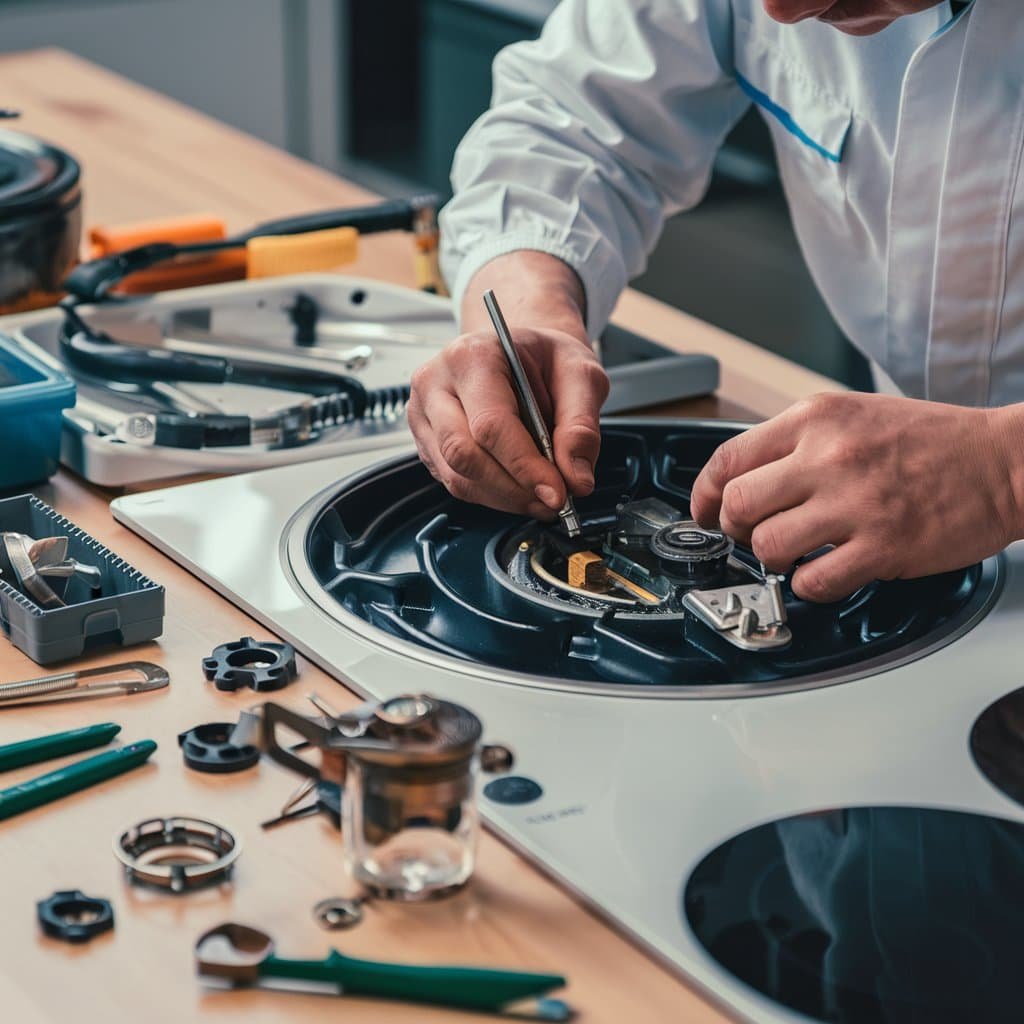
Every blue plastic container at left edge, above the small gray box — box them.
[0,334,75,489]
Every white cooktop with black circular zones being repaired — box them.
[113,420,1024,1024]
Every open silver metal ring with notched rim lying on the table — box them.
[114,815,242,893]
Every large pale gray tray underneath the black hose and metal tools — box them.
[0,273,718,486]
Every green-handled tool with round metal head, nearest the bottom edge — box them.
[196,924,572,1021]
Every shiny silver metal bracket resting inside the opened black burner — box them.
[683,573,793,650]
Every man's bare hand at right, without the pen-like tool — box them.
[690,393,1024,601]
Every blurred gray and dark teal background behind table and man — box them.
[0,0,867,386]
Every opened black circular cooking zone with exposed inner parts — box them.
[305,420,996,690]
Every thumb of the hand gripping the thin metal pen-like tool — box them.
[551,351,608,495]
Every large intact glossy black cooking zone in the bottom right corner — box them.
[683,807,1024,1024]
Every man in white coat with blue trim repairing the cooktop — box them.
[409,0,1024,601]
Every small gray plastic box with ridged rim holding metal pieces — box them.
[0,495,164,665]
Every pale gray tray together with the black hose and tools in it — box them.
[0,273,718,485]
